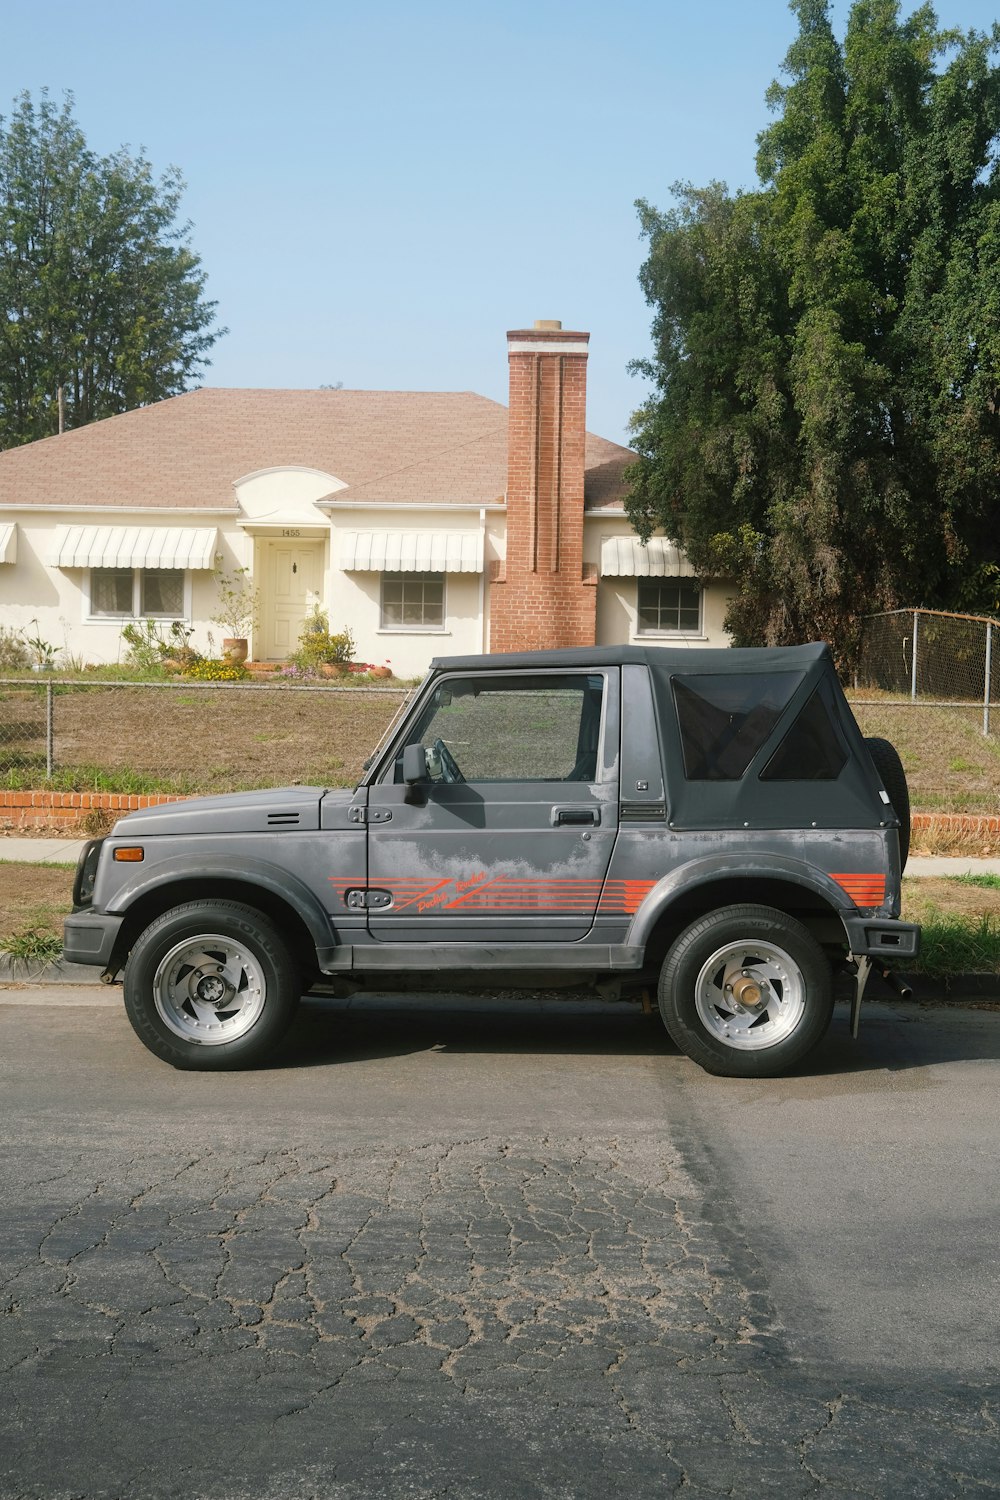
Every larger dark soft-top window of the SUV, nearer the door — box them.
[673,672,802,782]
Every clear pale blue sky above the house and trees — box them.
[0,0,1000,441]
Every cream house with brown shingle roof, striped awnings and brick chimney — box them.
[0,324,727,677]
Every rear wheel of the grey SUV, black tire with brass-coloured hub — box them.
[658,906,834,1079]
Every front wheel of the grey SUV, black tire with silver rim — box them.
[124,902,301,1073]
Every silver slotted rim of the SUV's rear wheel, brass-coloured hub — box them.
[694,939,805,1052]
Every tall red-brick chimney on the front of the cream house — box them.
[490,321,597,651]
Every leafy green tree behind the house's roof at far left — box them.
[0,93,225,447]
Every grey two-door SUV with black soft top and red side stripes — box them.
[66,645,919,1077]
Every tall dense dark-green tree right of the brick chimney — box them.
[628,0,1000,654]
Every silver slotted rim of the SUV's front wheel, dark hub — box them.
[153,933,267,1047]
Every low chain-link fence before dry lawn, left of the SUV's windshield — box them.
[0,677,406,792]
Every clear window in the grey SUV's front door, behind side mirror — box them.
[394,674,604,782]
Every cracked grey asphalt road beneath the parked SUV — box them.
[0,993,1000,1500]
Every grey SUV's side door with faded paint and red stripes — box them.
[367,671,618,944]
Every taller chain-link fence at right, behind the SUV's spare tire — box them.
[853,609,1000,735]
